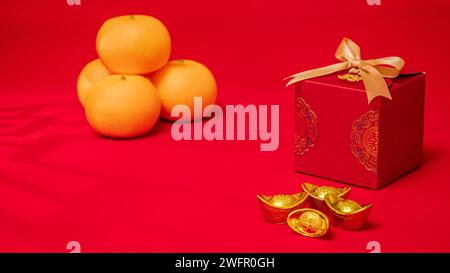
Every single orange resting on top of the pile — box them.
[96,15,171,74]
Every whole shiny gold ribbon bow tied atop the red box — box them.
[286,38,405,103]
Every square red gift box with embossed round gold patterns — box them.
[288,37,425,189]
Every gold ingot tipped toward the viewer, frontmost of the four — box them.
[287,208,330,237]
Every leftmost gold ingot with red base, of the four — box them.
[256,192,308,224]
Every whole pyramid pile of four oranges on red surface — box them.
[77,15,217,138]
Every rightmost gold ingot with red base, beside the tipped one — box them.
[325,194,372,230]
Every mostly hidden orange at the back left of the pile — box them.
[77,59,111,106]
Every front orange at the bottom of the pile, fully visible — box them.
[85,75,161,138]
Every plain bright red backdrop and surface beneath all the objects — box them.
[0,0,450,252]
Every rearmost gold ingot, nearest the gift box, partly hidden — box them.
[302,183,351,213]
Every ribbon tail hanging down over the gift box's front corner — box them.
[360,65,392,103]
